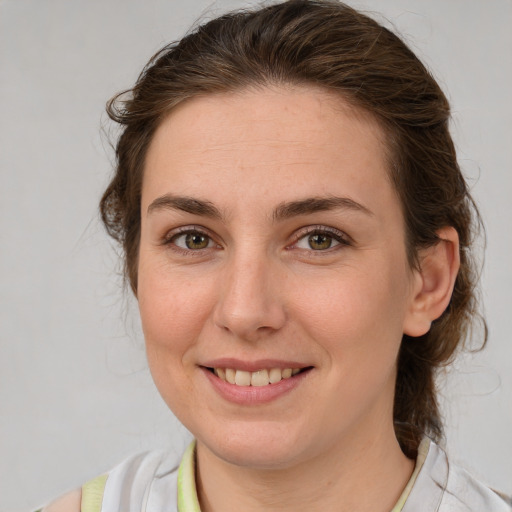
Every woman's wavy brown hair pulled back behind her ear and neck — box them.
[100,0,479,457]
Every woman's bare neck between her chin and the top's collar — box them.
[196,425,414,512]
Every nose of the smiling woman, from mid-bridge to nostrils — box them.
[214,252,286,341]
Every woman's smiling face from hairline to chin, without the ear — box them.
[138,87,419,467]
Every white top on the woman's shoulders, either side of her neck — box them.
[93,440,512,512]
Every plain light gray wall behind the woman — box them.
[0,0,512,512]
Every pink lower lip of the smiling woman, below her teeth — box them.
[201,367,311,405]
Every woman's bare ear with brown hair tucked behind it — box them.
[404,227,460,336]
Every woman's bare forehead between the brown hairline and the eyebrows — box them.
[143,87,390,215]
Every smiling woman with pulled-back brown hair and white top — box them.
[42,0,510,512]
